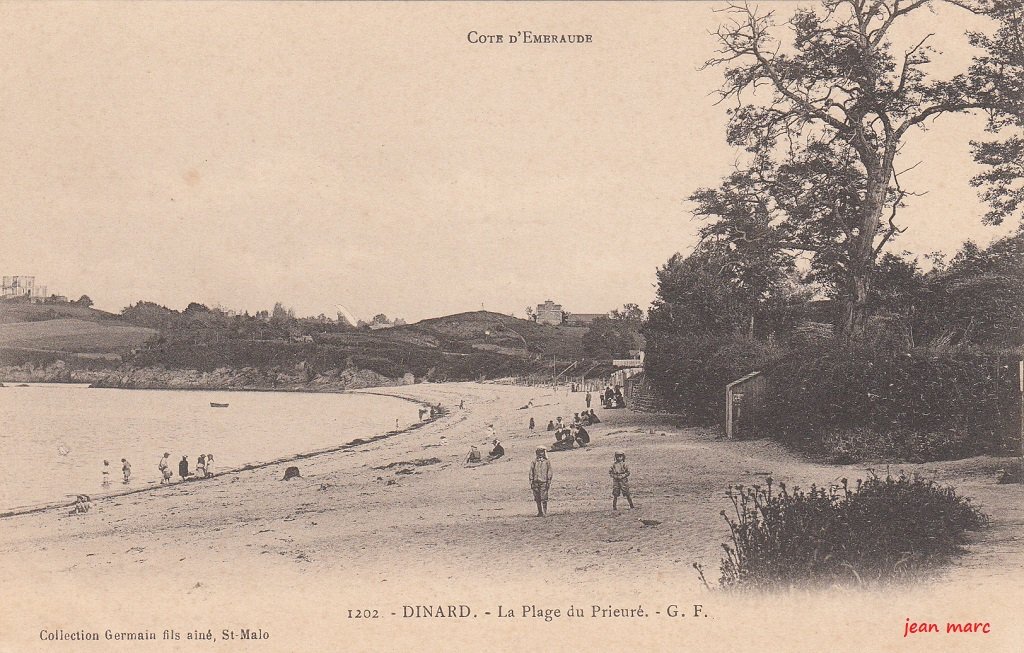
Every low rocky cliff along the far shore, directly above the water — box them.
[93,366,409,392]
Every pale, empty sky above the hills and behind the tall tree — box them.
[0,2,1007,320]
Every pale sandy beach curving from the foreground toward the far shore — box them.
[0,383,1024,651]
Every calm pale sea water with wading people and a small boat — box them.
[0,384,419,511]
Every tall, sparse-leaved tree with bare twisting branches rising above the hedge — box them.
[695,0,1022,338]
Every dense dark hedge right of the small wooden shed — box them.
[758,343,1019,462]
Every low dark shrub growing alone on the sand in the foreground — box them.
[720,476,986,590]
